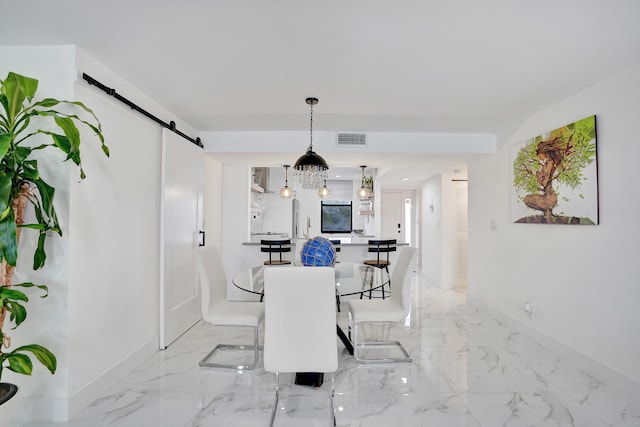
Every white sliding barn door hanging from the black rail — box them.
[160,129,204,349]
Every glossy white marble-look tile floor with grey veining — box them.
[32,273,640,427]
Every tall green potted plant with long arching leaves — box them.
[0,72,109,425]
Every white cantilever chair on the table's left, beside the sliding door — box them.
[196,246,264,370]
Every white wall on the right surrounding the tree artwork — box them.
[469,66,640,388]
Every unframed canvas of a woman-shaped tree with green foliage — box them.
[511,116,598,225]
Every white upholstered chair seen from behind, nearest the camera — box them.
[264,267,338,425]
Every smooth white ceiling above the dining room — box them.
[0,0,640,187]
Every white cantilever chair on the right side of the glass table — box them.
[349,247,418,363]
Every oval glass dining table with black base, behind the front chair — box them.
[232,262,389,355]
